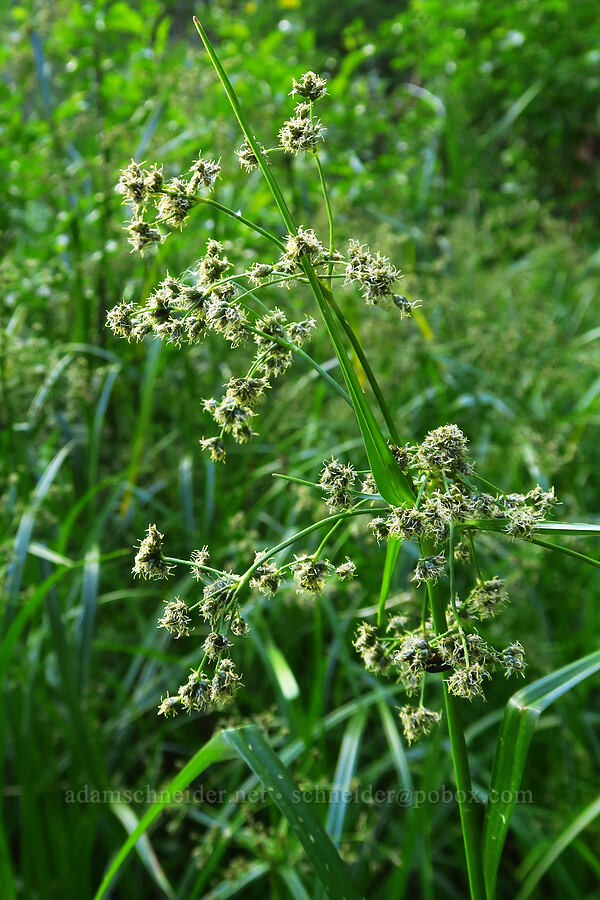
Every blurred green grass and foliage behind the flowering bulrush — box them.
[0,0,600,900]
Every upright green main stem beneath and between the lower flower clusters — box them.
[422,560,486,900]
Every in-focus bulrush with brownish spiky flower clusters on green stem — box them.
[108,22,597,898]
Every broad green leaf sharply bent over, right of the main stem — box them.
[483,650,600,900]
